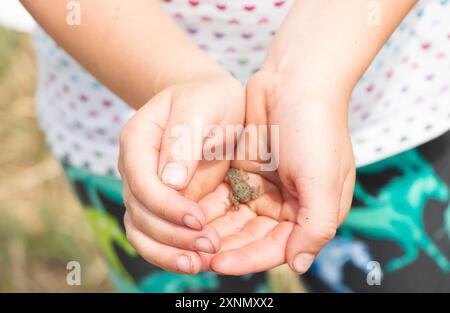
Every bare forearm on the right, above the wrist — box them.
[263,0,416,96]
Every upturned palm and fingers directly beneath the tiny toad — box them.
[199,163,296,275]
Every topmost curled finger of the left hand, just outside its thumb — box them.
[119,94,204,229]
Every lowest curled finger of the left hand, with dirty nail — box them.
[124,213,208,274]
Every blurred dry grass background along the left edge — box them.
[0,0,112,292]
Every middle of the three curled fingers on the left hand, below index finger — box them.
[124,186,220,253]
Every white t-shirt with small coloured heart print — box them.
[35,0,450,175]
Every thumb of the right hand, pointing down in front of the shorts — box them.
[286,177,342,273]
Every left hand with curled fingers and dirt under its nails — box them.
[119,76,245,274]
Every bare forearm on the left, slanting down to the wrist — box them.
[21,0,227,108]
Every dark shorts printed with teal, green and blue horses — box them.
[65,132,450,292]
